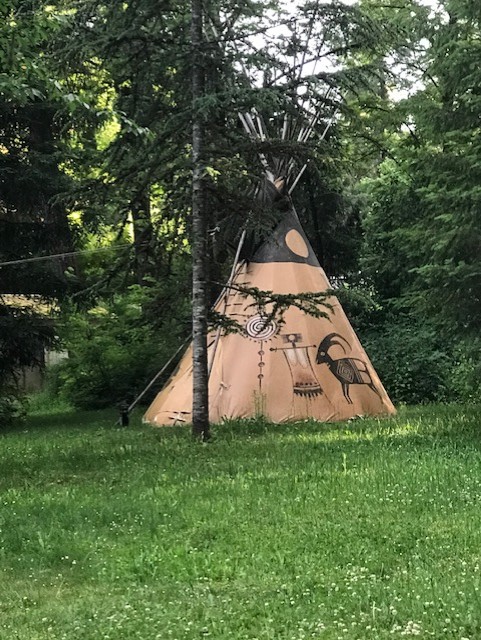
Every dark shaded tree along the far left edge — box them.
[0,0,73,410]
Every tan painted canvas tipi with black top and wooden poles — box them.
[144,108,395,425]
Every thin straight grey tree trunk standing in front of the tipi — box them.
[191,0,209,440]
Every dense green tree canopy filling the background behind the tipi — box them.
[0,0,481,416]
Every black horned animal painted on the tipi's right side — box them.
[316,333,381,404]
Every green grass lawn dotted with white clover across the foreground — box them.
[0,406,481,640]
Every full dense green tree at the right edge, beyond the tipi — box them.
[360,0,481,333]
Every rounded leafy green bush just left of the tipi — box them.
[49,286,188,409]
